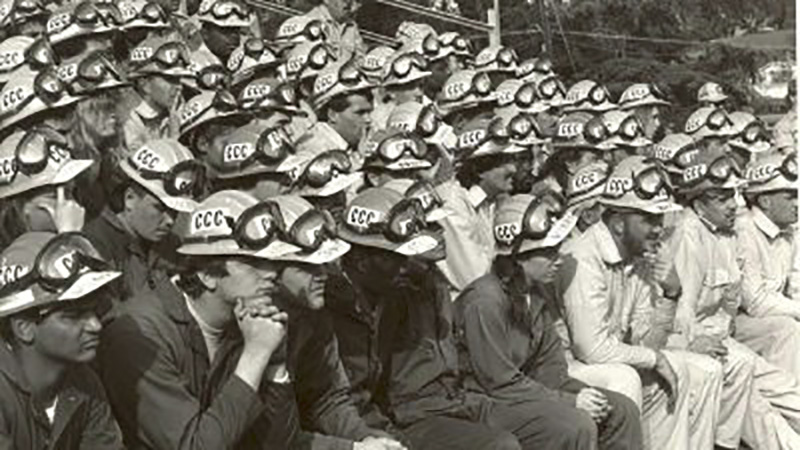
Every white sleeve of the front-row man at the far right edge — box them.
[736,230,800,319]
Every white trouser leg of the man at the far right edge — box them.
[734,314,800,378]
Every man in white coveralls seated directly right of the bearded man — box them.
[665,147,800,448]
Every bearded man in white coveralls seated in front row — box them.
[557,156,724,450]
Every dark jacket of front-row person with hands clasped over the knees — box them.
[455,274,587,406]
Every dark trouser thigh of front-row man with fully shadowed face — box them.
[402,416,522,450]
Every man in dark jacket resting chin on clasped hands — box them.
[100,191,391,450]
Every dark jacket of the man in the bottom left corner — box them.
[0,341,123,450]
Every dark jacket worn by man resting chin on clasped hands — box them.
[100,286,366,450]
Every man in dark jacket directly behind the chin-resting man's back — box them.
[84,139,203,308]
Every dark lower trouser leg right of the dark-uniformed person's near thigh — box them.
[598,388,642,450]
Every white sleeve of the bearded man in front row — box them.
[559,251,656,369]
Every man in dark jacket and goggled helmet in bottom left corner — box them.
[0,232,123,450]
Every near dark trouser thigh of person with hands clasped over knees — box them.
[478,399,597,450]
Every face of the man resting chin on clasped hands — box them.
[217,258,279,312]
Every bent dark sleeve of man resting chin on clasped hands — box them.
[101,316,265,449]
